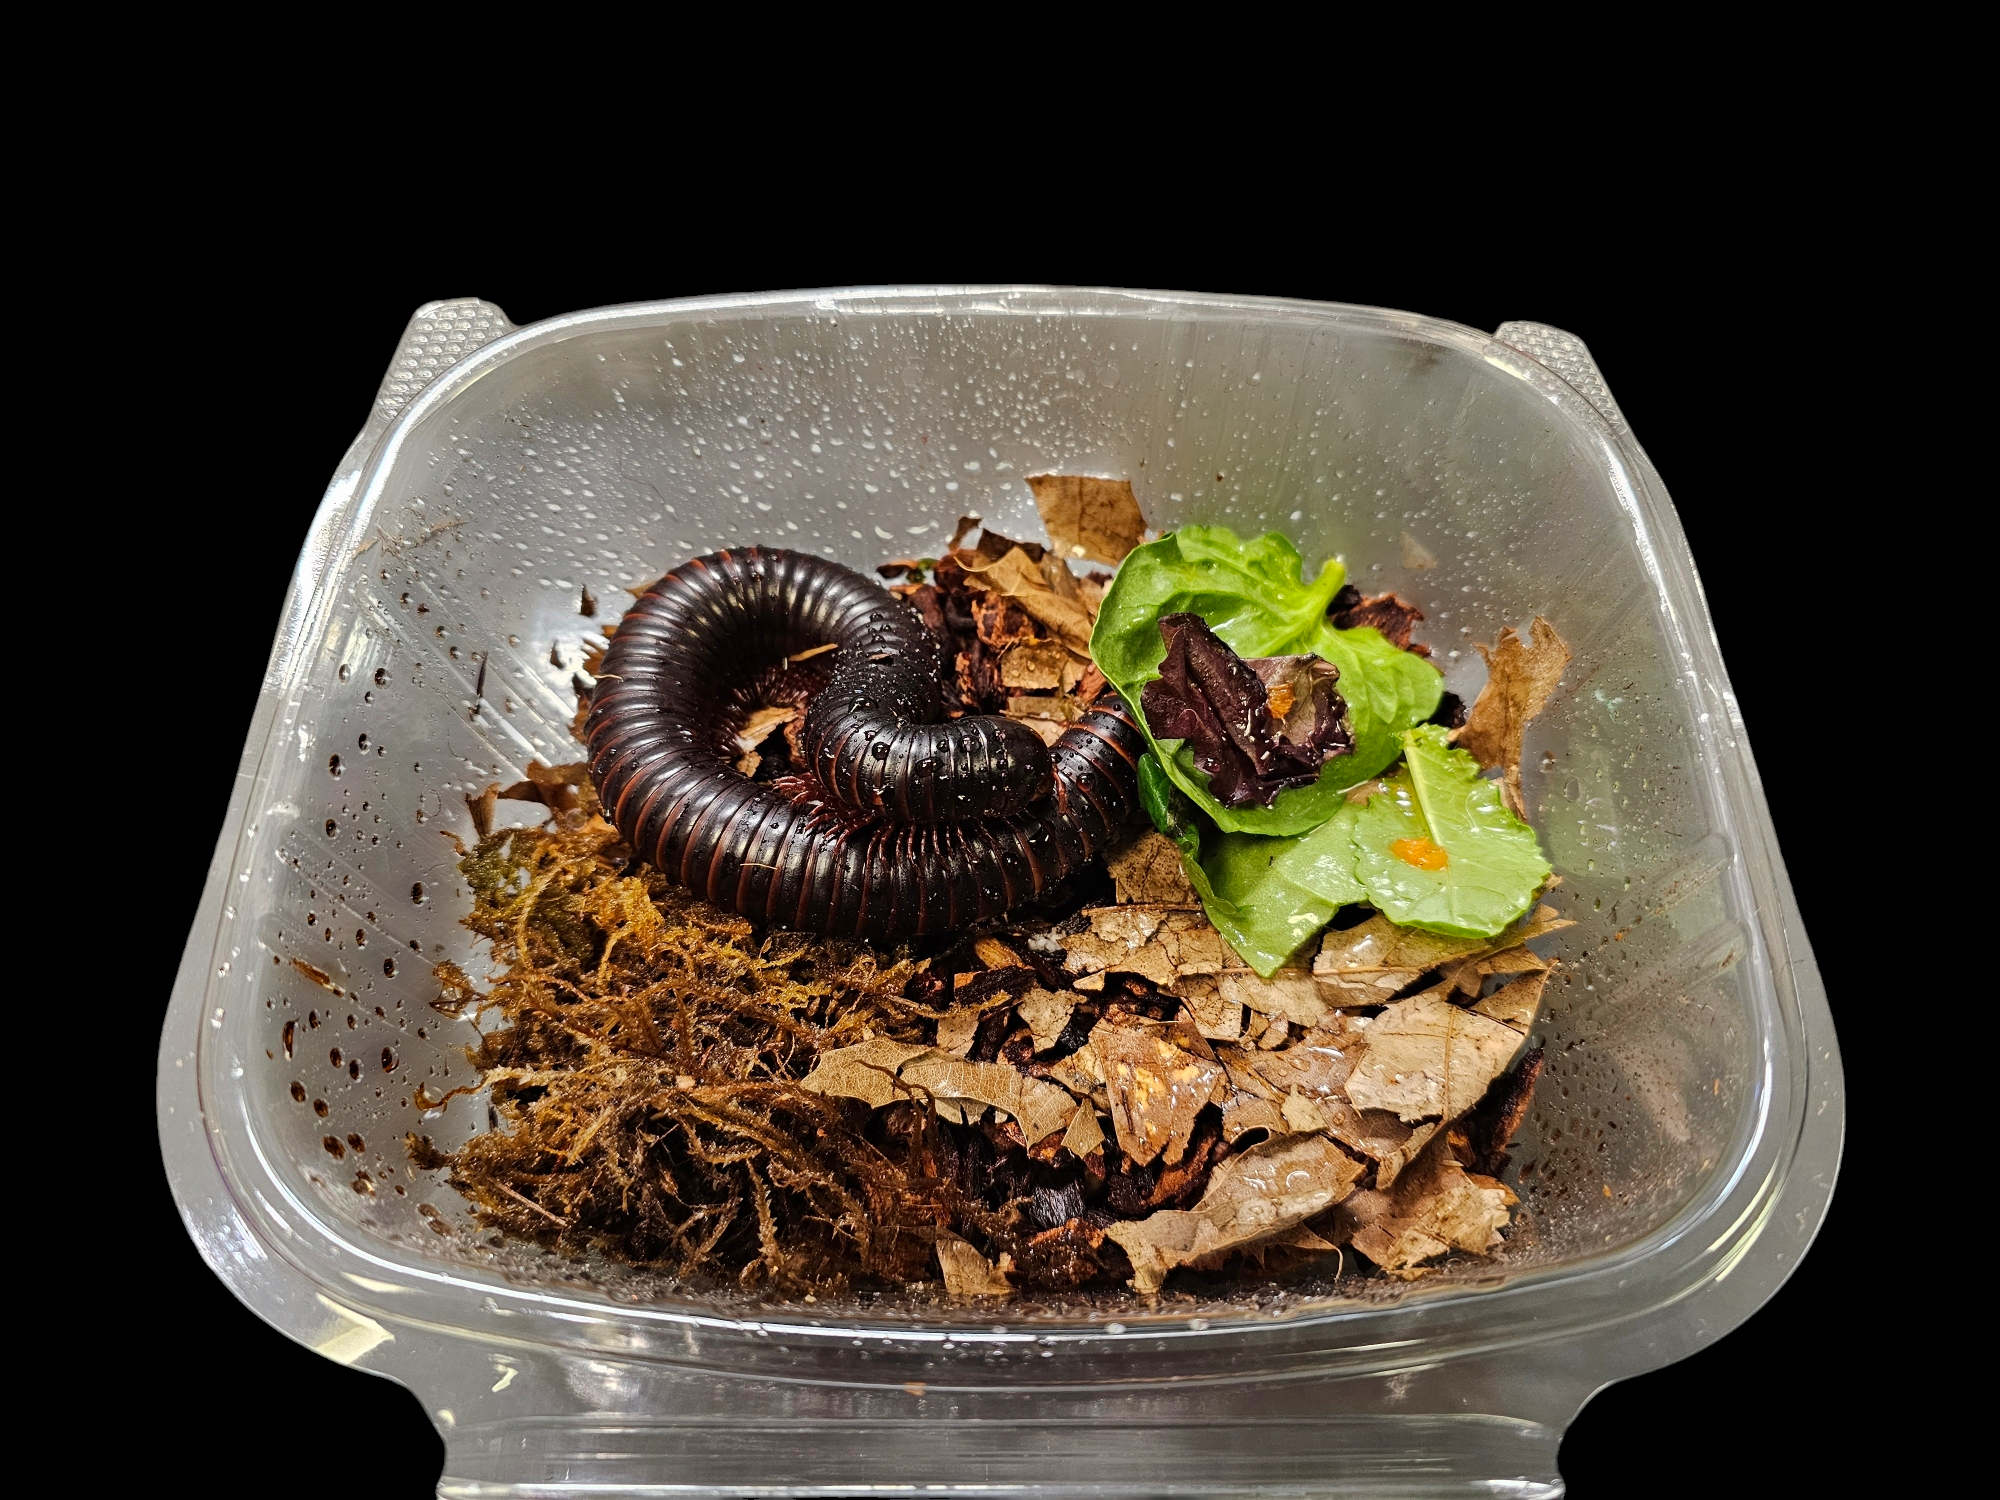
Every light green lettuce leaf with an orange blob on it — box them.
[1352,724,1548,938]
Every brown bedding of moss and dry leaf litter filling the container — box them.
[408,488,1570,1298]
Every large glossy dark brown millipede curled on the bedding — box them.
[586,546,1144,938]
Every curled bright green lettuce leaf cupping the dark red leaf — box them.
[1090,526,1444,836]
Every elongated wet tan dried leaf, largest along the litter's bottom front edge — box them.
[1104,1136,1362,1294]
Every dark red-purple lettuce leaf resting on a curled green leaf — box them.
[1140,612,1354,808]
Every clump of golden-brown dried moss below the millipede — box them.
[412,768,1056,1290]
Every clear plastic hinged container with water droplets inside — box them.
[160,288,1842,1496]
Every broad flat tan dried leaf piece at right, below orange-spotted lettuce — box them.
[1346,990,1520,1122]
